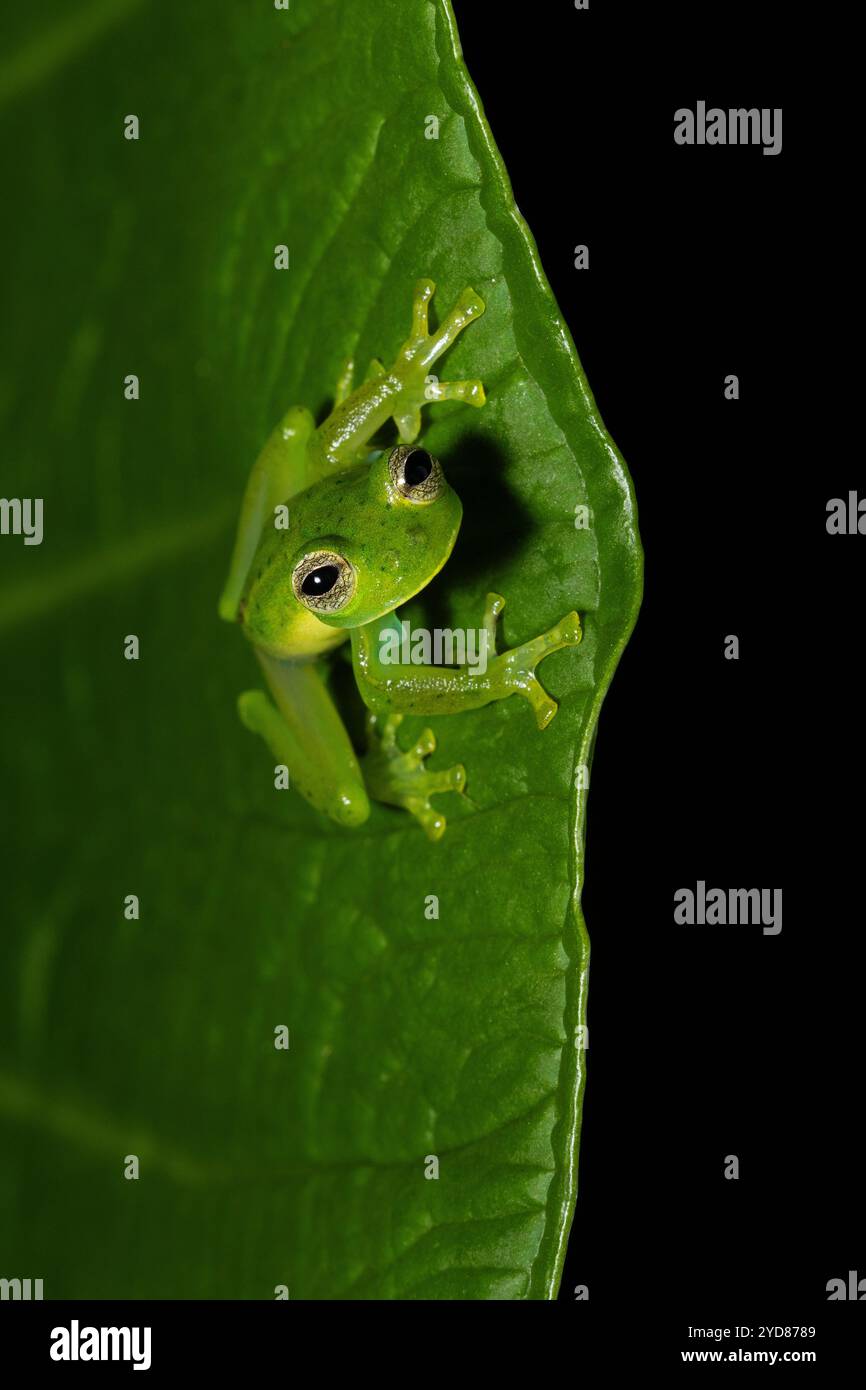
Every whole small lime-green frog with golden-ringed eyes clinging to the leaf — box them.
[220,279,581,840]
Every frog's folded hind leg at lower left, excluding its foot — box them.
[238,652,370,827]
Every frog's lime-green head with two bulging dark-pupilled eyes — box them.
[243,445,463,651]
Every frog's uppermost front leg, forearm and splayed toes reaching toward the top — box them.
[307,279,484,474]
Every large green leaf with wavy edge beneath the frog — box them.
[0,0,641,1298]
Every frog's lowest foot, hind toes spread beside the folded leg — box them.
[361,713,466,840]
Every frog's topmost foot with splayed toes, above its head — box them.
[391,279,484,443]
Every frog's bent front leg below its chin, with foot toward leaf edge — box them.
[352,594,582,728]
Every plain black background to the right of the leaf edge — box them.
[455,0,866,1323]
